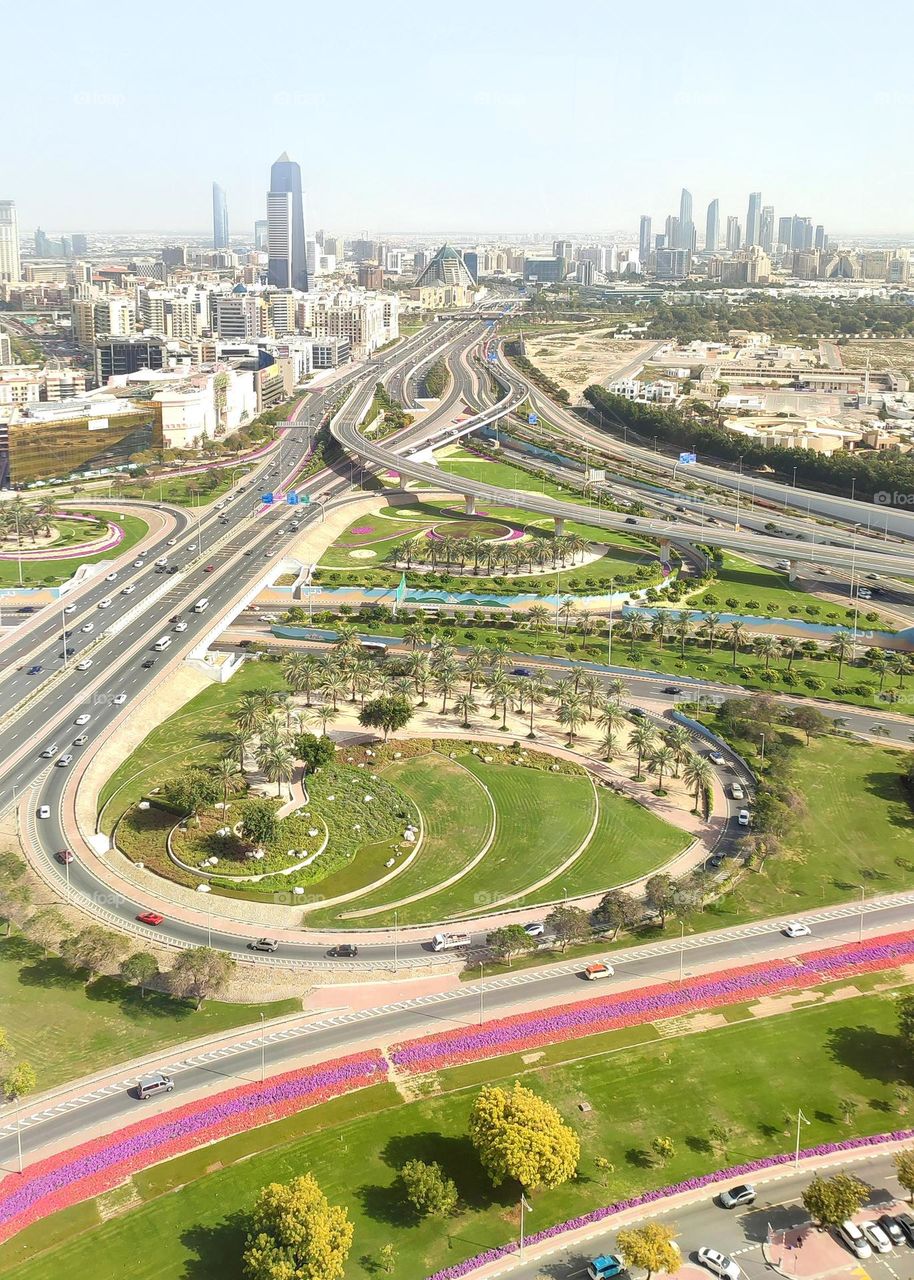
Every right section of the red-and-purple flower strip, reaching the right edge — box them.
[390,932,914,1073]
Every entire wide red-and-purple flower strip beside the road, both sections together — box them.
[0,931,914,1249]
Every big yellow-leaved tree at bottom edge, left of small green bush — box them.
[243,1174,352,1280]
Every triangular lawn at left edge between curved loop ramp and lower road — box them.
[0,933,301,1089]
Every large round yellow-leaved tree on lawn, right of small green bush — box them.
[469,1082,581,1190]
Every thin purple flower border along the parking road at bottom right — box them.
[428,1129,914,1280]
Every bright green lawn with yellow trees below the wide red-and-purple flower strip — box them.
[0,975,914,1280]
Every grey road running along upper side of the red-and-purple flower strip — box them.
[0,892,914,1162]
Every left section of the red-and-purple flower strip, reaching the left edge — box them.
[0,1051,387,1242]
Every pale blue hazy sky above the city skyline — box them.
[8,0,914,236]
